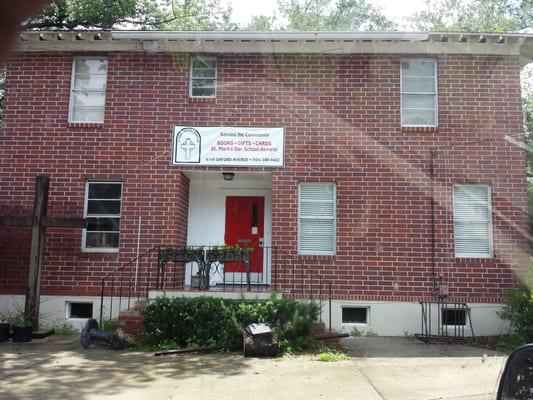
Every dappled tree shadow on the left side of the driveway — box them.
[0,341,246,400]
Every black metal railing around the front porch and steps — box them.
[100,246,332,328]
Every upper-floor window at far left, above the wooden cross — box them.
[69,57,107,123]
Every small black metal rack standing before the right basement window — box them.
[418,300,475,342]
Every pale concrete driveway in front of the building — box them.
[0,337,505,400]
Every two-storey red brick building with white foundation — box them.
[0,31,533,335]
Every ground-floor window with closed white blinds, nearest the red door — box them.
[298,183,336,255]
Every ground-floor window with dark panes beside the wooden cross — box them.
[82,181,122,251]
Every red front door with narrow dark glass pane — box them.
[224,196,265,272]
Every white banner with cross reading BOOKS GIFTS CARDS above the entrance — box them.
[172,126,285,167]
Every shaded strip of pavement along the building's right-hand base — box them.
[340,337,503,358]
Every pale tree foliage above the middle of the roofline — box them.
[278,0,395,31]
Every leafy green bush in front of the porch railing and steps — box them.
[143,296,318,351]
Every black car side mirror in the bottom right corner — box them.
[496,344,533,400]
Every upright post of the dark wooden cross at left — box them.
[24,175,50,330]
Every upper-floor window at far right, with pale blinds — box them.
[400,59,437,126]
